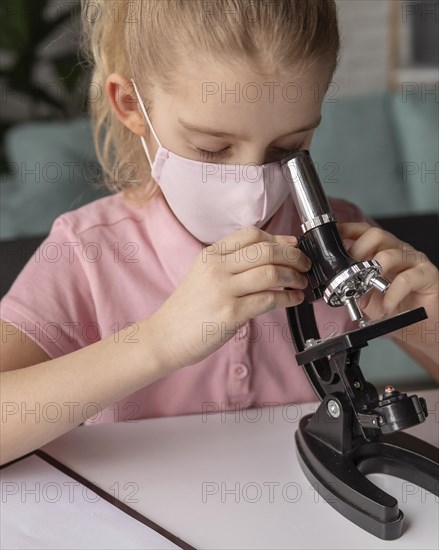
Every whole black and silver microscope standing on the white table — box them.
[281,149,439,540]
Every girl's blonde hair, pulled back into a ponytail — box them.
[81,0,340,205]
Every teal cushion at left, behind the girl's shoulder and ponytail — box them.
[0,117,108,240]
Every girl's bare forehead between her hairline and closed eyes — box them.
[154,57,330,139]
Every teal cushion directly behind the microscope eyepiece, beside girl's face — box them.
[311,92,410,217]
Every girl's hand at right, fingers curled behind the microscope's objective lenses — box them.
[337,222,439,350]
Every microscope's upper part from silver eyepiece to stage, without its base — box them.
[281,149,428,438]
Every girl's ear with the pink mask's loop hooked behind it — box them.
[105,73,146,136]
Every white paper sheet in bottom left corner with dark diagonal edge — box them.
[0,453,181,550]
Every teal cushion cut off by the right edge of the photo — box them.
[391,86,439,212]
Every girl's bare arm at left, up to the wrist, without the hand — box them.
[0,315,181,464]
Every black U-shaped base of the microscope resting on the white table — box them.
[295,410,439,540]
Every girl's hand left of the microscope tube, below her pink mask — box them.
[152,226,311,369]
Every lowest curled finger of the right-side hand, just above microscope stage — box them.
[383,265,432,314]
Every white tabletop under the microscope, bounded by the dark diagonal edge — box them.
[1,390,439,550]
